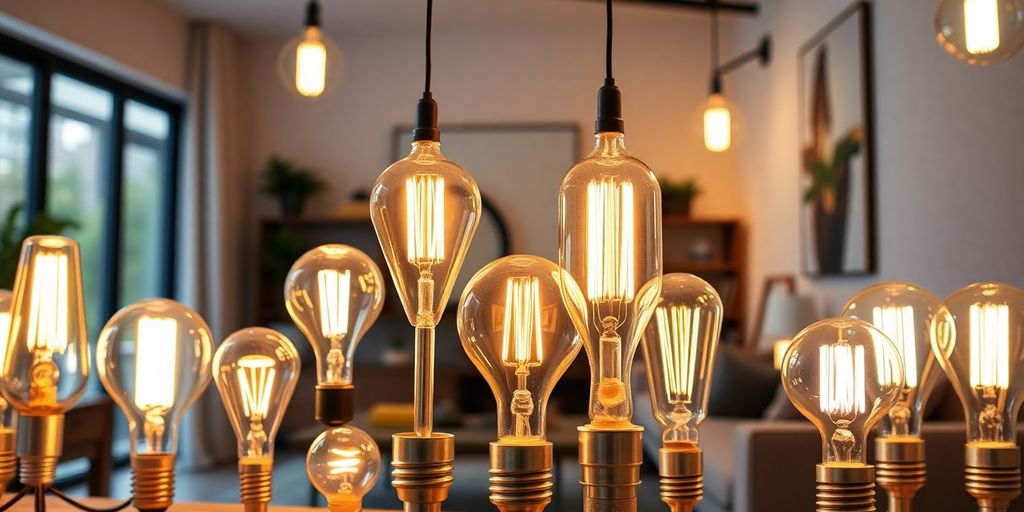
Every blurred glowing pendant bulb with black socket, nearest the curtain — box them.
[278,0,341,97]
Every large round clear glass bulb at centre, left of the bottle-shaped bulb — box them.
[459,255,583,443]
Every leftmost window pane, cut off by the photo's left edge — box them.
[0,56,36,226]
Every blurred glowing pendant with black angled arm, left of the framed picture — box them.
[700,0,771,153]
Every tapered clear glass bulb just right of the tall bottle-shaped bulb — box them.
[643,273,723,447]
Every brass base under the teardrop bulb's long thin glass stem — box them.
[391,432,455,512]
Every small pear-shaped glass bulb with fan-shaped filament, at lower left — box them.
[213,328,301,462]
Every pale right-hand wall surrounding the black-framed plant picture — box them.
[729,0,1024,323]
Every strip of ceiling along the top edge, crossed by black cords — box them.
[162,0,720,36]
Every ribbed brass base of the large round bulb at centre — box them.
[489,441,554,512]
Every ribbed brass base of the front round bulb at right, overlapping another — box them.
[815,464,874,512]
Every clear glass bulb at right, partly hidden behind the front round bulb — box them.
[842,282,942,437]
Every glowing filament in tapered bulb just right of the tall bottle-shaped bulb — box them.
[654,306,708,402]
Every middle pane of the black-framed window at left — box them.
[46,75,114,340]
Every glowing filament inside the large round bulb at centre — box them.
[502,278,544,367]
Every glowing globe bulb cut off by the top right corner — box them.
[935,0,1024,66]
